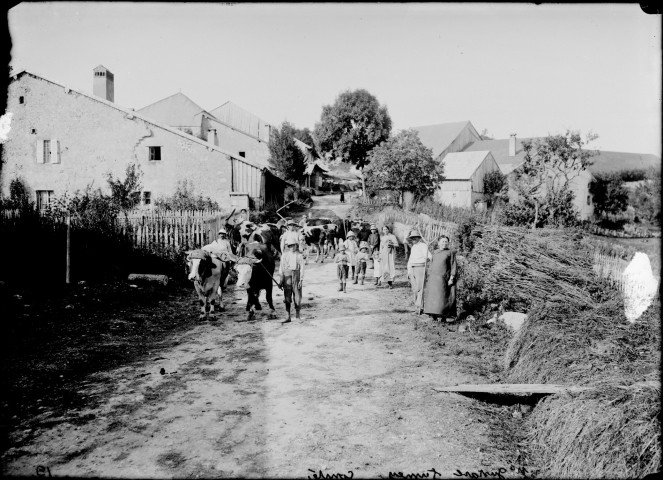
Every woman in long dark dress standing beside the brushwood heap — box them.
[424,235,457,321]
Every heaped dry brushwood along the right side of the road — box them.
[459,225,661,478]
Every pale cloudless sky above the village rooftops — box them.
[8,2,662,157]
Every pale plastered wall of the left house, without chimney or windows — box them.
[0,74,261,207]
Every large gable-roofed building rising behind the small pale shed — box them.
[412,120,481,161]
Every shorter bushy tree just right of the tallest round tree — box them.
[364,130,444,206]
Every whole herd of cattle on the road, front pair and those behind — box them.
[187,213,370,319]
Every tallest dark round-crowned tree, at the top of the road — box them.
[315,89,391,191]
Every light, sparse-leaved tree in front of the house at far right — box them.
[514,130,598,228]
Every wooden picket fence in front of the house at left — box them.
[118,210,228,250]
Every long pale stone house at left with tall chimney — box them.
[0,66,291,208]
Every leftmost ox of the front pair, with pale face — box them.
[186,250,231,318]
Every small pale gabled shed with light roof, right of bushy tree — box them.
[435,150,499,208]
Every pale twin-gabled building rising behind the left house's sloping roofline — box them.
[137,93,271,167]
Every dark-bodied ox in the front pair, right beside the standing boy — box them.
[235,242,275,320]
